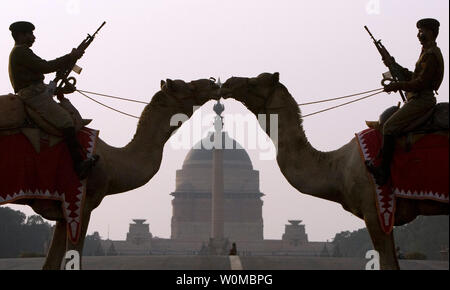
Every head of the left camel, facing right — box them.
[157,79,219,112]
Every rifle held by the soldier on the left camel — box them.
[50,21,106,94]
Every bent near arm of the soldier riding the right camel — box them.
[399,53,438,92]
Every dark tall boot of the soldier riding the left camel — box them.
[63,127,99,180]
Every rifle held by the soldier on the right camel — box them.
[364,25,408,102]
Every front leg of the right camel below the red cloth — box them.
[364,213,400,270]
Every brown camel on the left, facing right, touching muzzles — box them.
[9,79,219,269]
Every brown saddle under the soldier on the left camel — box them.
[0,94,92,152]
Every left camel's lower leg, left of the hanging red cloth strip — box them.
[42,220,67,270]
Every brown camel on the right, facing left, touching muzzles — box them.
[220,73,449,269]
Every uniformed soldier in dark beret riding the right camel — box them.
[367,18,444,185]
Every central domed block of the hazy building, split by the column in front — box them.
[171,132,263,242]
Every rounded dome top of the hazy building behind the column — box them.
[183,132,253,170]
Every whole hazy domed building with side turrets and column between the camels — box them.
[102,103,331,256]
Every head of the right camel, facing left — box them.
[219,72,281,114]
